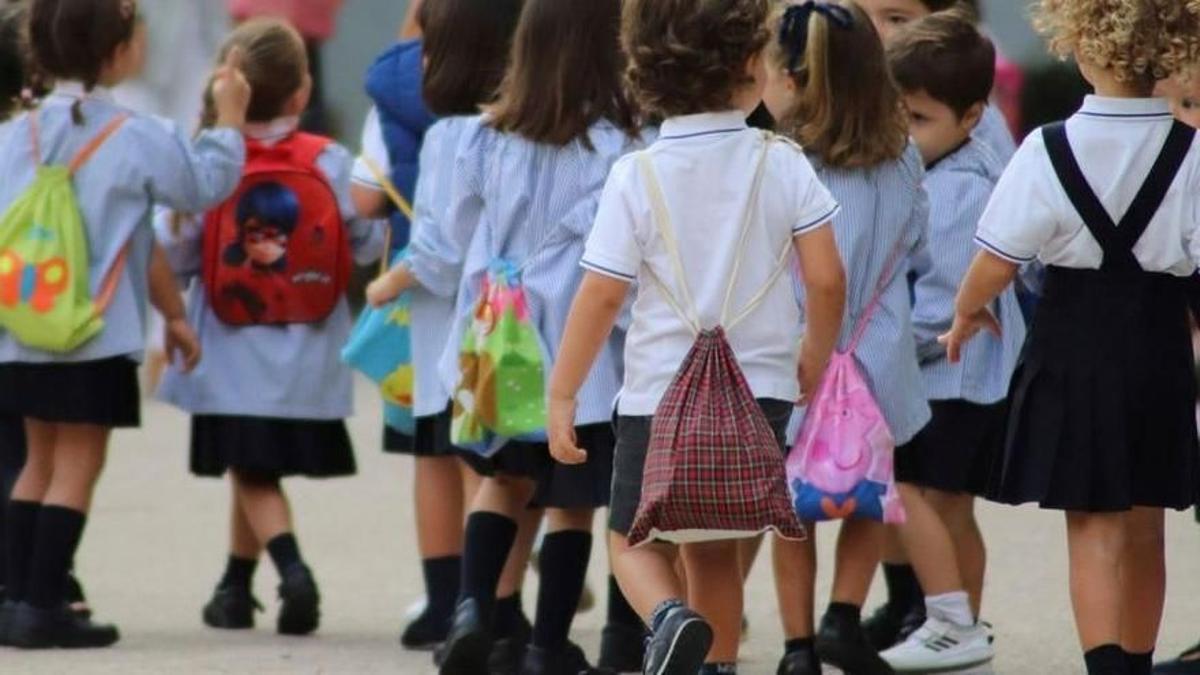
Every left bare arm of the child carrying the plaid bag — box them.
[547,271,630,464]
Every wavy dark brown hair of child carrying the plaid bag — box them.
[622,0,770,117]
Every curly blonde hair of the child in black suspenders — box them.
[1034,0,1200,83]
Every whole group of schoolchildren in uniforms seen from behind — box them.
[0,0,1200,675]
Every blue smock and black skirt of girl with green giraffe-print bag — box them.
[436,118,641,508]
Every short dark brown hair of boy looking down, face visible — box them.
[888,10,996,119]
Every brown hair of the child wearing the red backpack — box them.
[202,18,308,126]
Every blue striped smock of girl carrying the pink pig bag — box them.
[797,144,930,446]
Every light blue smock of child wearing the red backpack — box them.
[155,119,386,420]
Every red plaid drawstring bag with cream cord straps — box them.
[629,135,804,545]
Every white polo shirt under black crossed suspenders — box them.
[976,96,1200,276]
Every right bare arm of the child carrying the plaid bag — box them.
[796,225,846,402]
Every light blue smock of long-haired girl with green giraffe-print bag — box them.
[427,118,642,425]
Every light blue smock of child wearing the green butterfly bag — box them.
[0,82,246,363]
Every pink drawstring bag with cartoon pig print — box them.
[787,245,905,524]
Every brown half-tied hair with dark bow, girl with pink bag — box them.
[768,2,908,168]
